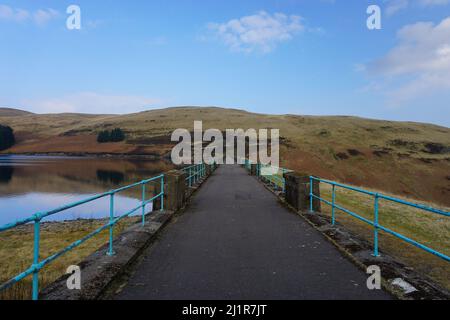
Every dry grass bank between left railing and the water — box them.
[0,217,138,300]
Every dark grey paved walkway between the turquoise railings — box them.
[116,165,390,300]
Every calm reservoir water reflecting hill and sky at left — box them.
[0,156,172,225]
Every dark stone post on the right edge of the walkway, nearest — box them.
[284,172,320,212]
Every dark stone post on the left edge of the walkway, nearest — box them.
[164,170,186,211]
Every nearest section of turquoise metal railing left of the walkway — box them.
[0,174,164,300]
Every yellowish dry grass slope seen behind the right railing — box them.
[320,183,450,289]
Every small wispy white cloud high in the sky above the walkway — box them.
[208,11,304,53]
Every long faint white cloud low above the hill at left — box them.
[22,92,161,114]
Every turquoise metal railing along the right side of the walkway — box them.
[244,160,450,261]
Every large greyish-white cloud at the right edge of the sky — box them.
[366,17,450,104]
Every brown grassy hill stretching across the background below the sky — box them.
[0,107,450,206]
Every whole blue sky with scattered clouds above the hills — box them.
[0,0,450,127]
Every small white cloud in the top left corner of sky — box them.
[0,4,59,26]
